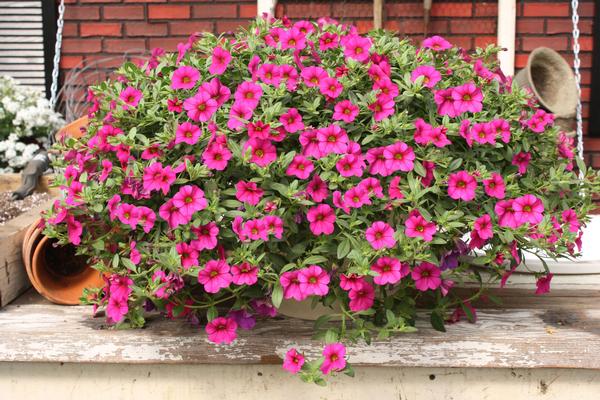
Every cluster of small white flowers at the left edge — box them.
[0,76,64,173]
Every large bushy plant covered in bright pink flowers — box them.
[45,19,598,383]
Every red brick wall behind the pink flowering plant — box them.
[61,0,600,168]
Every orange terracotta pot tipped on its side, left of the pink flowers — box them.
[23,222,104,305]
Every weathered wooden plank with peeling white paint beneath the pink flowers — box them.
[0,304,600,369]
